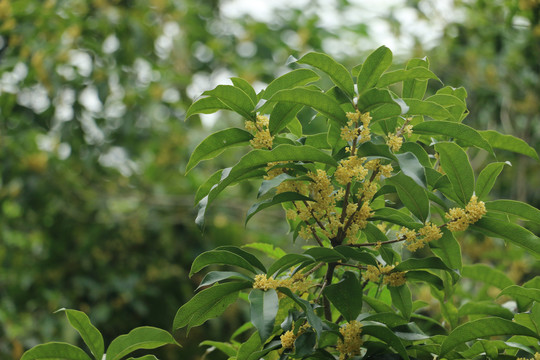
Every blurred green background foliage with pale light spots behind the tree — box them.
[0,0,540,358]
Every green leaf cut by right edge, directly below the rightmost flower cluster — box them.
[471,216,540,256]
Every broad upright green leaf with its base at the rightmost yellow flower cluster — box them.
[435,142,474,205]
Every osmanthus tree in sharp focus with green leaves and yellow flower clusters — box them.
[19,46,540,360]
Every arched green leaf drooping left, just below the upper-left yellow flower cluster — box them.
[186,128,253,174]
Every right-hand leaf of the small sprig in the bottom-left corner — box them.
[107,326,180,360]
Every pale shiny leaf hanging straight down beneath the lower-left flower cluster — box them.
[249,289,279,343]
